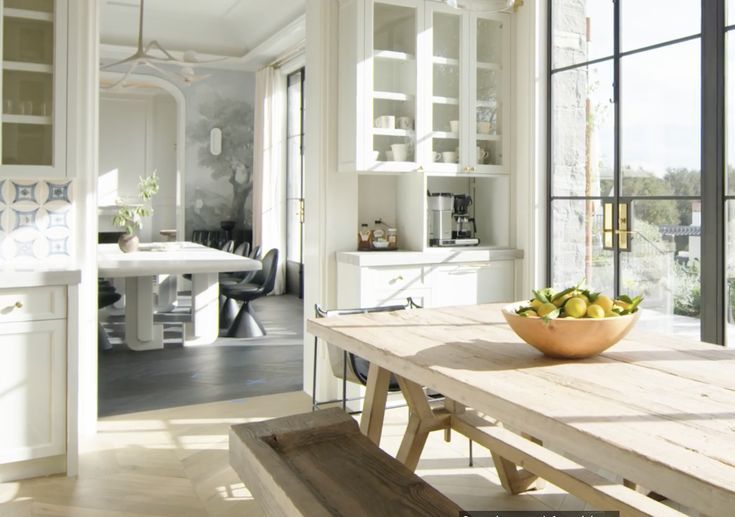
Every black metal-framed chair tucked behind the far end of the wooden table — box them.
[311,298,419,411]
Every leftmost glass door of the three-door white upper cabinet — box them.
[366,0,421,172]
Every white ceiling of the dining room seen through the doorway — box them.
[100,0,306,67]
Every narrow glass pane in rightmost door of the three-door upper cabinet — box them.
[474,18,505,165]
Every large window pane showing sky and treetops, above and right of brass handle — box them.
[621,40,702,196]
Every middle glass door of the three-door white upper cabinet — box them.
[426,5,467,173]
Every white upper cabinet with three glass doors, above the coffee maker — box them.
[338,0,513,251]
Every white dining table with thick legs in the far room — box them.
[97,242,261,350]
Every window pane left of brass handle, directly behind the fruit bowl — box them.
[551,199,614,294]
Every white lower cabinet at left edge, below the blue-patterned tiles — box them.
[0,286,67,465]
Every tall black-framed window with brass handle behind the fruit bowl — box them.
[548,0,704,338]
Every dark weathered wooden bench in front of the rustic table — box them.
[230,408,460,517]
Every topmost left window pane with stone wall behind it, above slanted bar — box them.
[551,0,614,68]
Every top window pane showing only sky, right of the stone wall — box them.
[620,0,702,52]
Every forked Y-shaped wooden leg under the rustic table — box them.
[396,377,449,470]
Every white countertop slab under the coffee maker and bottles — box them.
[337,246,523,267]
